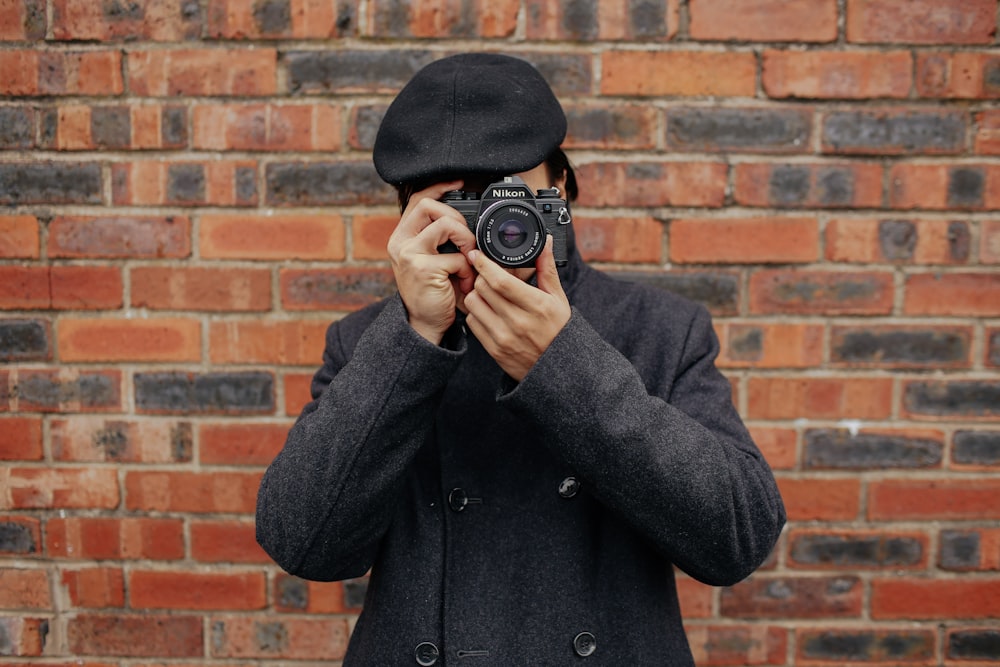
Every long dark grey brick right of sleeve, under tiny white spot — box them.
[805,429,943,470]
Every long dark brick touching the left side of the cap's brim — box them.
[266,162,395,206]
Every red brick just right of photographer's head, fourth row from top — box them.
[576,161,728,207]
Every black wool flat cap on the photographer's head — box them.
[372,53,566,185]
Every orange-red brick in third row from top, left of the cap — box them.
[192,104,341,152]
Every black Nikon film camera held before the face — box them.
[438,176,572,268]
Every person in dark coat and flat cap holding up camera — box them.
[257,53,785,667]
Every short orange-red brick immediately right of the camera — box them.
[573,216,664,264]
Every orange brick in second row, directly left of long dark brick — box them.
[127,47,278,97]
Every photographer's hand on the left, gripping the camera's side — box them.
[388,181,476,345]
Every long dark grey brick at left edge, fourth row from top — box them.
[0,162,102,206]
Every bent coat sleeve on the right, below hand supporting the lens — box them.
[500,307,785,586]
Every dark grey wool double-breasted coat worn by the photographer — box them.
[257,251,785,667]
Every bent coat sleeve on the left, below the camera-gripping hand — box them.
[257,297,464,581]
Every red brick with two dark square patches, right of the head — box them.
[733,163,883,208]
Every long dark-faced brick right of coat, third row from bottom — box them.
[789,535,924,568]
